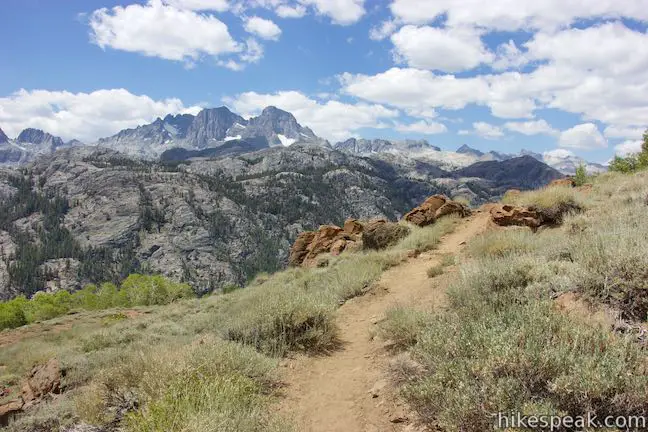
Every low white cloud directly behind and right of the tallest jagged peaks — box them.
[224,91,399,141]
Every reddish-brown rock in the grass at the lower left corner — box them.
[0,359,63,426]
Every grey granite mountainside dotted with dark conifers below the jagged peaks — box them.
[0,144,456,299]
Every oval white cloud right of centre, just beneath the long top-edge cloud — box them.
[391,25,493,72]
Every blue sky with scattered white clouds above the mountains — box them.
[0,0,648,162]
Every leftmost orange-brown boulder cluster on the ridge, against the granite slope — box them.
[289,219,364,267]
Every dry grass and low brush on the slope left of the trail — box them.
[0,216,453,432]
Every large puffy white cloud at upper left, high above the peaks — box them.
[90,0,241,62]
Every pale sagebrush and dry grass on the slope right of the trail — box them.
[383,173,648,432]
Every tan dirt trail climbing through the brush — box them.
[279,212,489,432]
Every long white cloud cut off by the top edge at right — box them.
[391,0,648,31]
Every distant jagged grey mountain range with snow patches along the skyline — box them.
[0,106,606,175]
